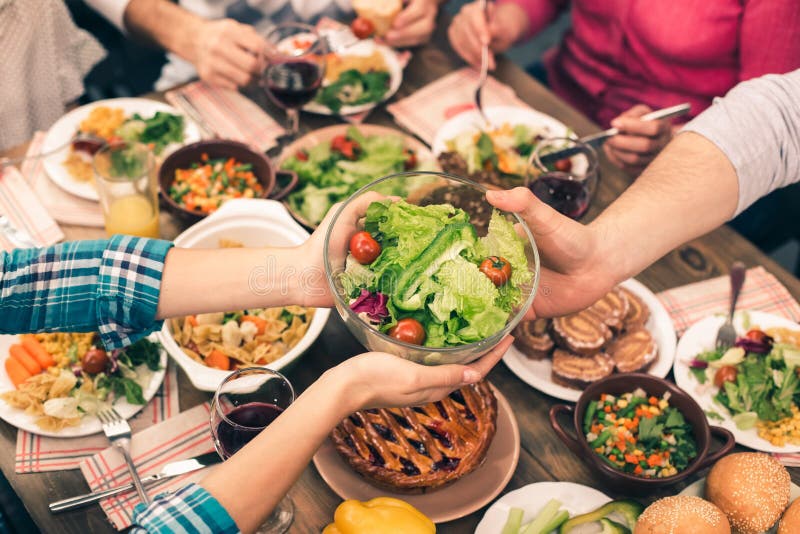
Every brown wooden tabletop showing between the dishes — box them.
[0,24,800,533]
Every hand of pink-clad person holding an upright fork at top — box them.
[447,2,528,70]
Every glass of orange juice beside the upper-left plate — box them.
[93,142,159,238]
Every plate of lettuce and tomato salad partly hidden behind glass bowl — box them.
[278,124,437,228]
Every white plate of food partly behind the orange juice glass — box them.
[42,98,200,201]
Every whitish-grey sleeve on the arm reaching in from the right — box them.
[682,69,800,215]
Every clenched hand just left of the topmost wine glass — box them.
[191,19,267,89]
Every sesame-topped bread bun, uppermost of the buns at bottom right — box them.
[706,452,791,534]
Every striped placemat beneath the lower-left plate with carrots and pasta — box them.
[14,363,180,473]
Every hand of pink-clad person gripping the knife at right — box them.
[603,104,672,176]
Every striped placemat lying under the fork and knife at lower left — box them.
[80,403,214,530]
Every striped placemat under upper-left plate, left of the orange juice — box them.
[21,132,104,228]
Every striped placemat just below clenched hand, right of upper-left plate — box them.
[166,82,284,152]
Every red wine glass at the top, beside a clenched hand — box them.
[261,22,327,136]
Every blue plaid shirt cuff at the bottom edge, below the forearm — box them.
[131,484,239,534]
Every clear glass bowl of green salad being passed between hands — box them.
[324,171,539,365]
